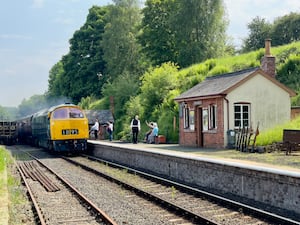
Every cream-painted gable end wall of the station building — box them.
[224,74,291,132]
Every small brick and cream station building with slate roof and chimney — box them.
[175,39,296,148]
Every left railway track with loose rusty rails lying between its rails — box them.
[12,148,116,225]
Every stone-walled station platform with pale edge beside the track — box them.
[88,140,300,221]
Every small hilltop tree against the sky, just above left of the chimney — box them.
[242,17,273,52]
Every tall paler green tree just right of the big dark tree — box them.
[101,0,143,81]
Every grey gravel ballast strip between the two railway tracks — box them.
[11,146,193,225]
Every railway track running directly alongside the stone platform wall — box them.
[67,156,299,225]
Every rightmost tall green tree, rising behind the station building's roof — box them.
[171,0,227,67]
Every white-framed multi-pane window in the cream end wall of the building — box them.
[234,103,250,128]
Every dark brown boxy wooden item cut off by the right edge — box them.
[281,129,300,155]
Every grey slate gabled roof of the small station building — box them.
[175,67,296,102]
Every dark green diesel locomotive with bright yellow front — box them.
[17,103,89,152]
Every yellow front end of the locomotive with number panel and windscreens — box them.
[48,104,89,151]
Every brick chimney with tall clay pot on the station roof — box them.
[260,39,276,78]
